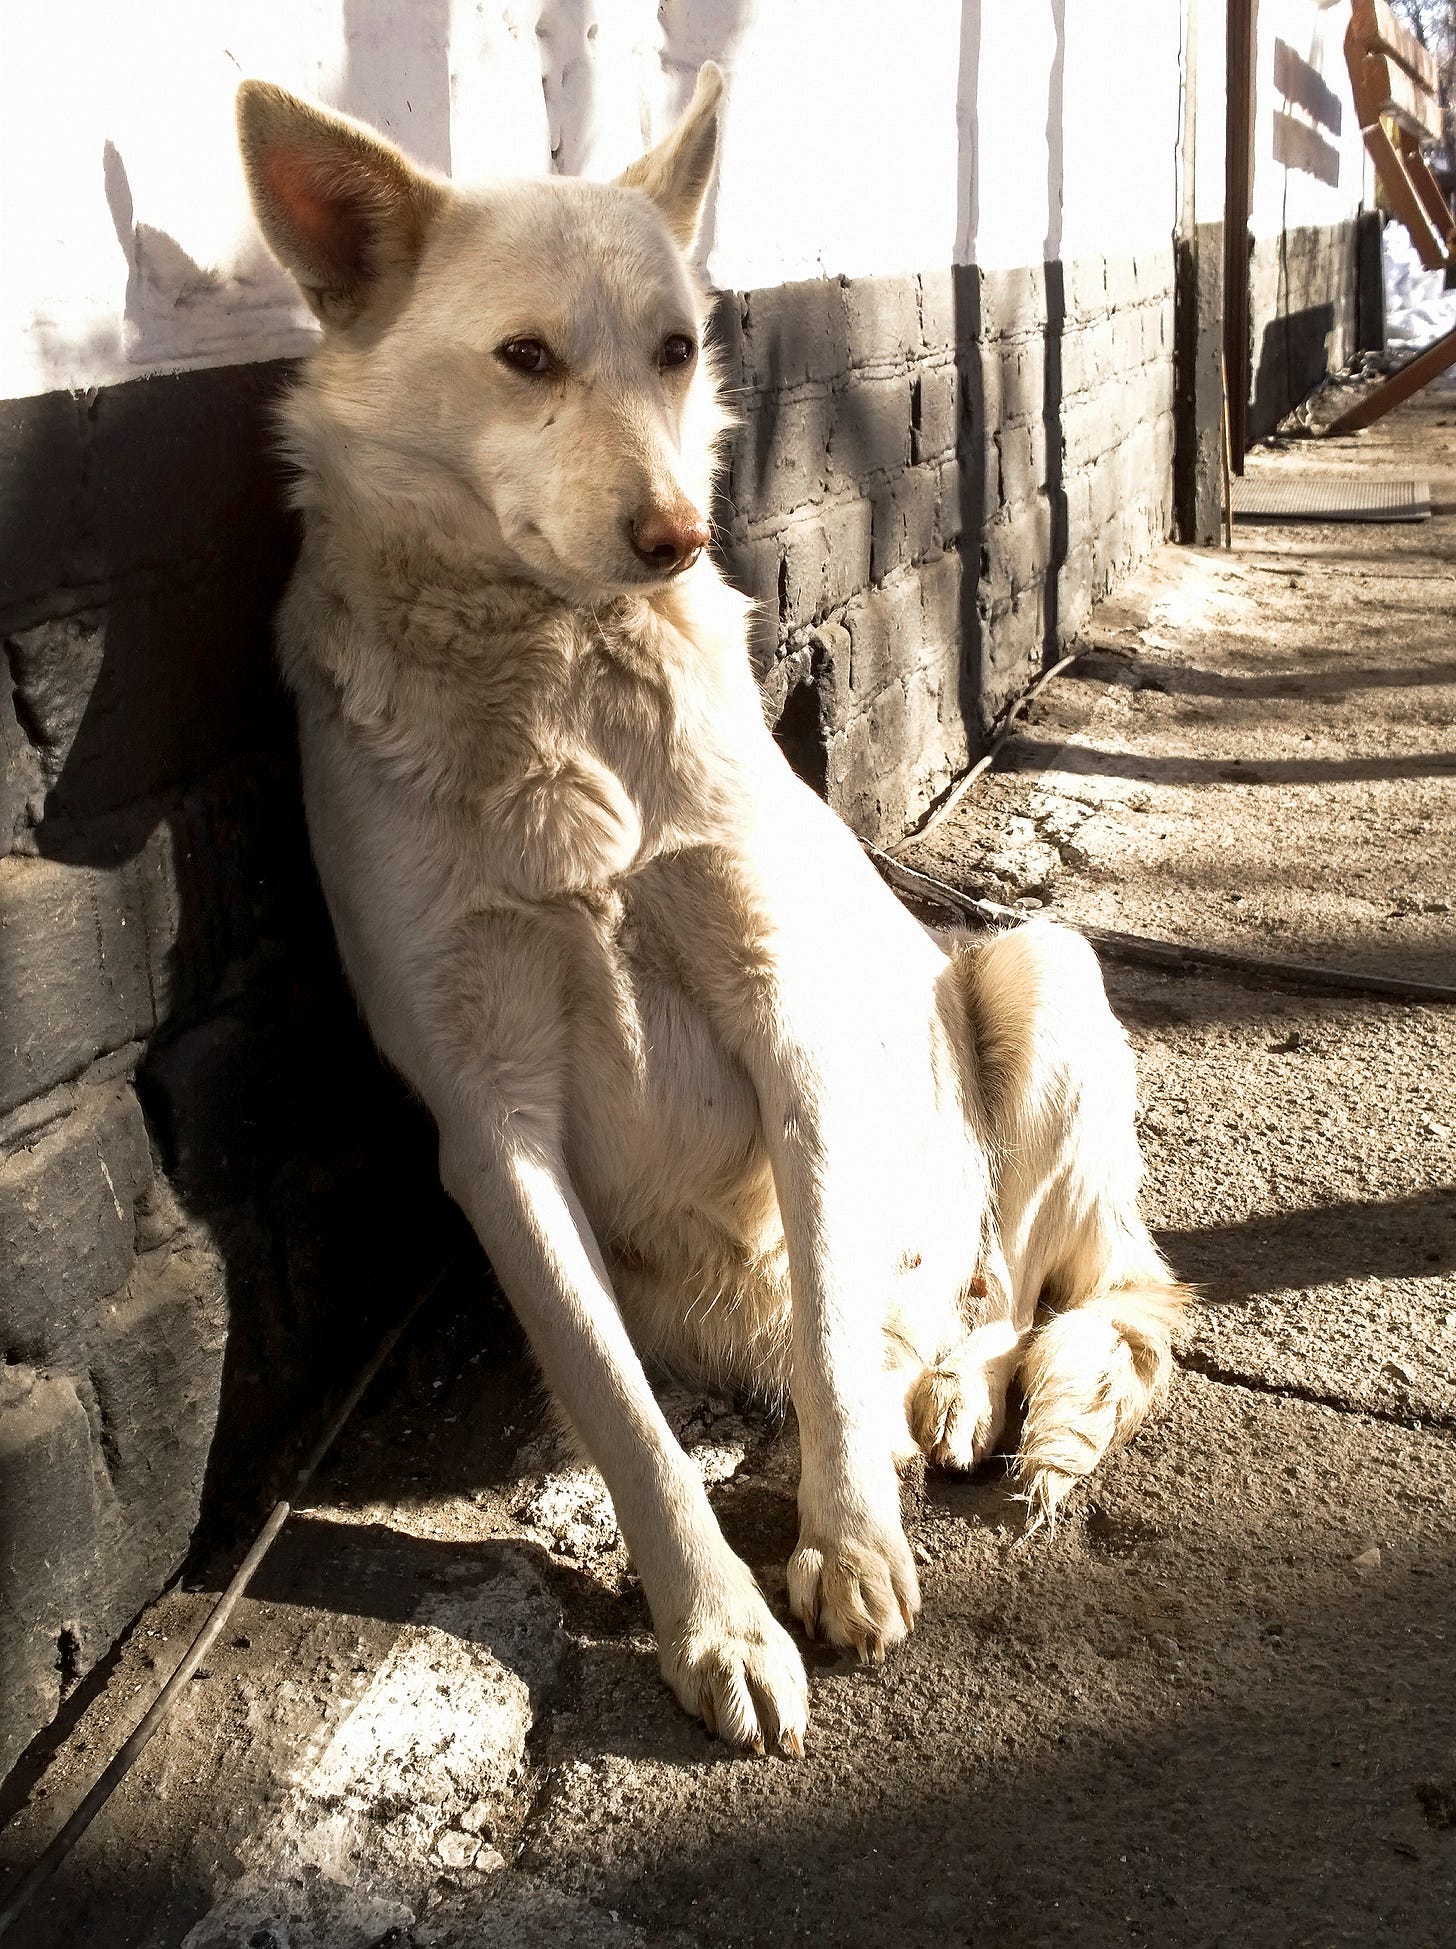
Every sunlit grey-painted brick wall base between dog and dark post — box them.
[715,248,1173,842]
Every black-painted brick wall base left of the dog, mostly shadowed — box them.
[0,366,452,1774]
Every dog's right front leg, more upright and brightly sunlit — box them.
[651,838,920,1659]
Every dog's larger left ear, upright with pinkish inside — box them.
[238,82,448,325]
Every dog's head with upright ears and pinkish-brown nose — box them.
[238,62,725,602]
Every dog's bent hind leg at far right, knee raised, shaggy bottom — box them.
[957,922,1187,1522]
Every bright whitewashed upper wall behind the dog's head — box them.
[0,0,1185,398]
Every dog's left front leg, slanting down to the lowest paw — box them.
[429,920,809,1752]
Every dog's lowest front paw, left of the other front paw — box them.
[659,1569,809,1758]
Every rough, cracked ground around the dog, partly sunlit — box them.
[0,380,1456,1949]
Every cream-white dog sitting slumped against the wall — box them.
[240,66,1181,1752]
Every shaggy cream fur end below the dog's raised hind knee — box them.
[1017,1271,1193,1530]
